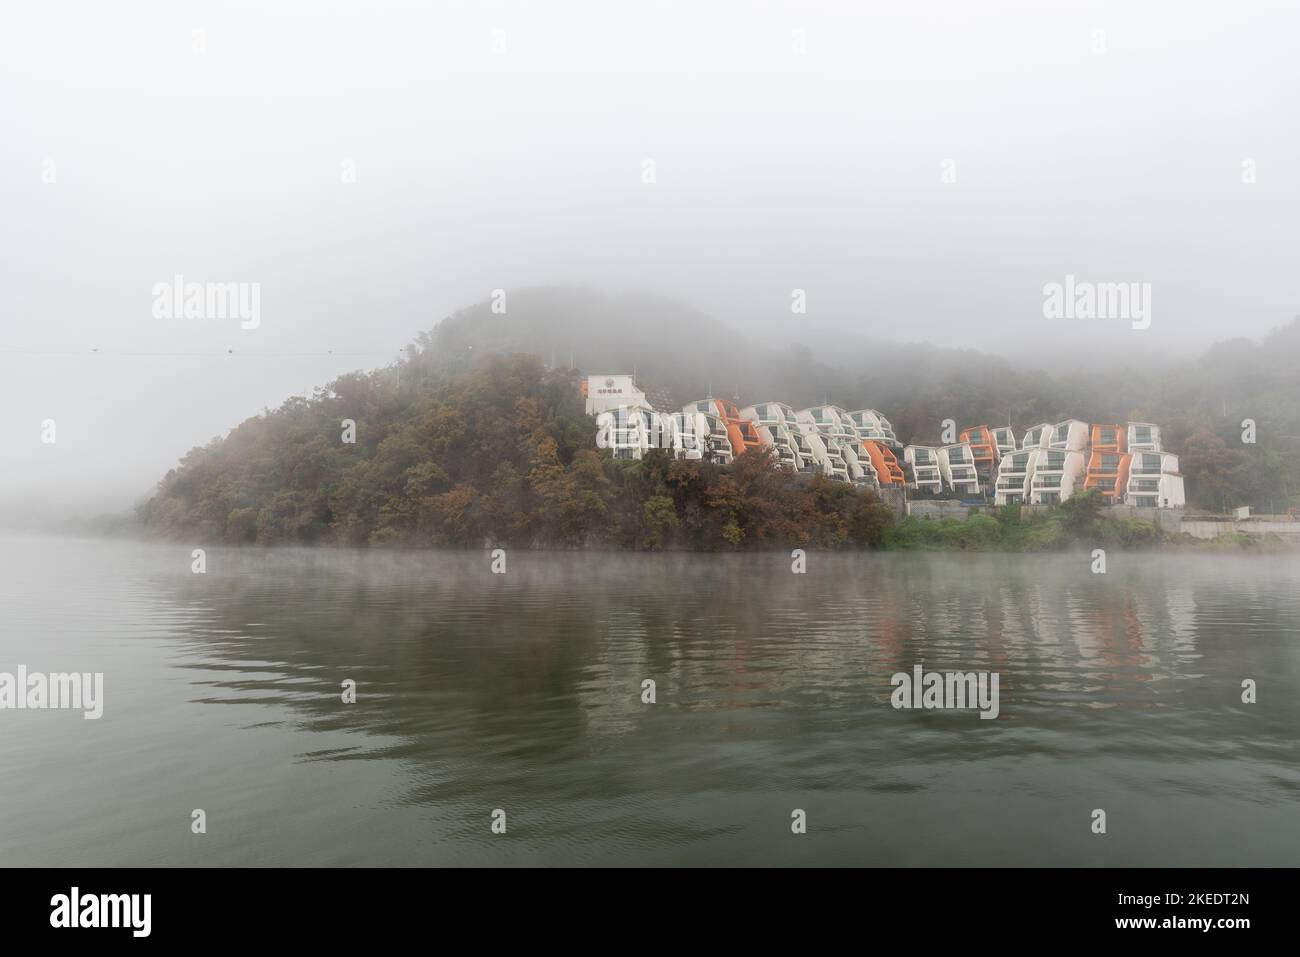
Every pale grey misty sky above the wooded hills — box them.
[0,0,1300,520]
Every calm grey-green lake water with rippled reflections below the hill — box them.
[0,538,1300,866]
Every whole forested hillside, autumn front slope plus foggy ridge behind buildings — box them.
[139,289,1300,549]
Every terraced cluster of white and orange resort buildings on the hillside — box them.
[581,376,1186,508]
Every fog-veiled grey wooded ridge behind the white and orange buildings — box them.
[420,289,1300,511]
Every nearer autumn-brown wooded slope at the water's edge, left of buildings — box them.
[140,351,889,549]
